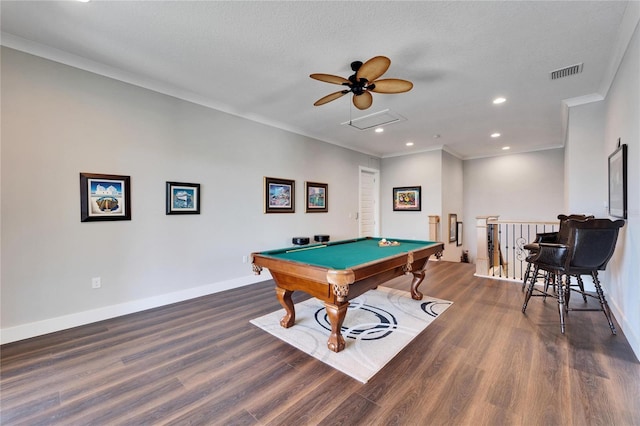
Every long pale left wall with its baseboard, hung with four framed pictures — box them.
[1,48,380,343]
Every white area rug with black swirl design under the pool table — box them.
[251,287,452,383]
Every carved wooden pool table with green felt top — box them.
[252,237,444,352]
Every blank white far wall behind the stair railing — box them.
[464,149,573,262]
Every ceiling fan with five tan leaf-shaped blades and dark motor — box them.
[309,56,413,109]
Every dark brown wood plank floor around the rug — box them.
[0,262,640,425]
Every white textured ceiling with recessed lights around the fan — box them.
[1,0,627,158]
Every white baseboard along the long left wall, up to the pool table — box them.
[0,270,271,344]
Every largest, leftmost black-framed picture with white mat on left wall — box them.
[80,173,131,222]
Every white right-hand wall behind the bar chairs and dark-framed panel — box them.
[566,8,640,358]
